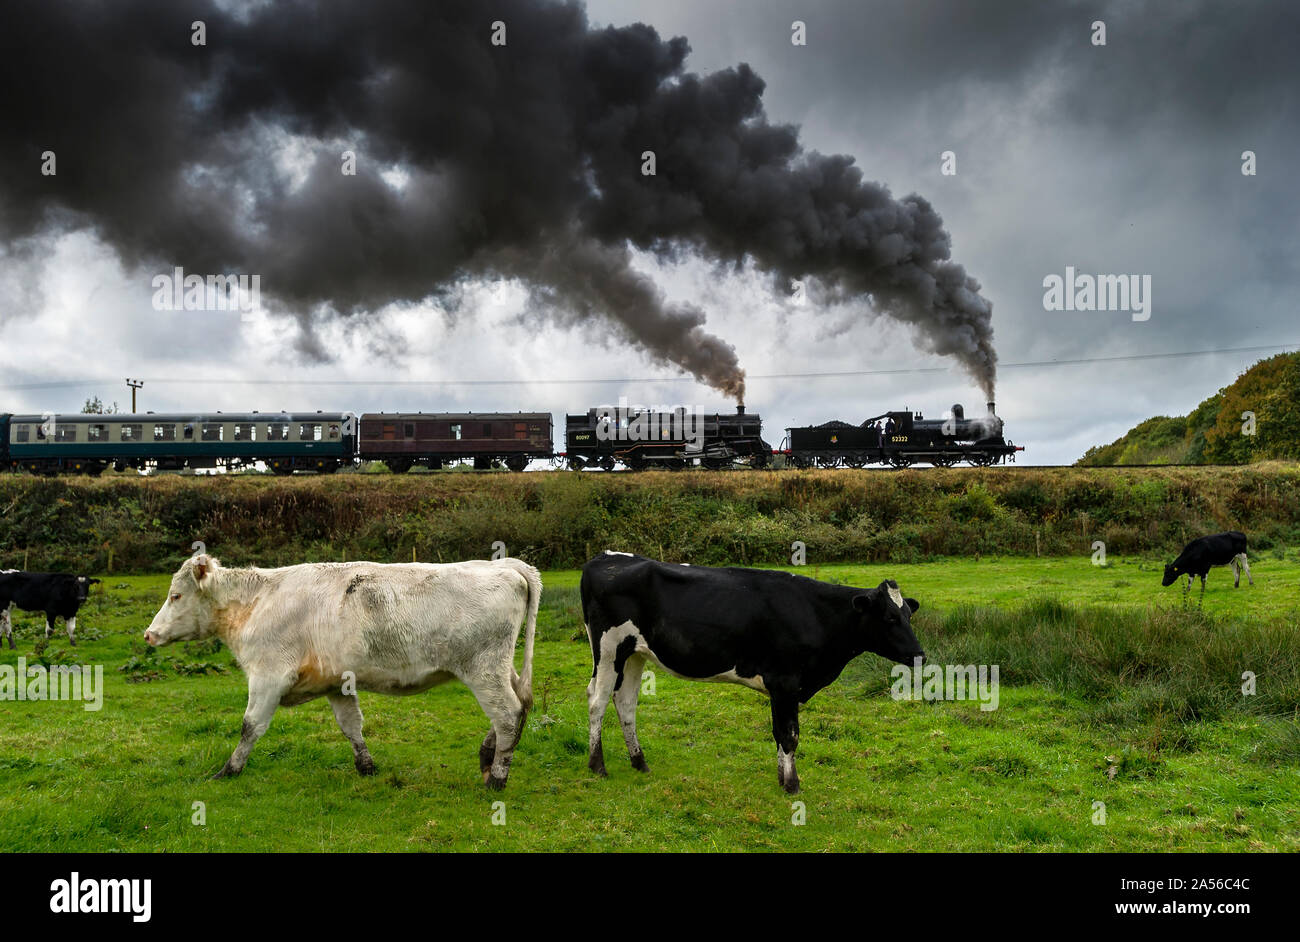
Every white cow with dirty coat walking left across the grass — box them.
[144,555,542,789]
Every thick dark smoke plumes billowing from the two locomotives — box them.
[0,0,996,398]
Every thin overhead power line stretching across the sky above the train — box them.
[0,343,1300,390]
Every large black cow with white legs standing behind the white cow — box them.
[581,552,924,794]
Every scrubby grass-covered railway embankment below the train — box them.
[0,463,1300,572]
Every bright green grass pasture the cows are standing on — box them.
[0,550,1300,851]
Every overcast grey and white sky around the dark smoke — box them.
[0,0,1300,464]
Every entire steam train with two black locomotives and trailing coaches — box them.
[0,403,1023,476]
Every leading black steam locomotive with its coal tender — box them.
[781,403,1024,468]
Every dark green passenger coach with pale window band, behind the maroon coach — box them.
[0,412,356,474]
